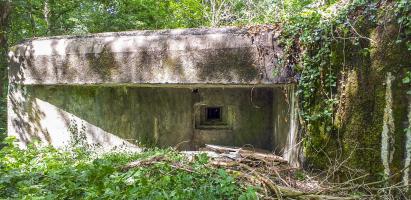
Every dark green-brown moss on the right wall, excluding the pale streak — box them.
[305,5,411,178]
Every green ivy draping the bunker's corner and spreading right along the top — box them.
[281,0,411,144]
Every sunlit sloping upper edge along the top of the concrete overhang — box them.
[9,27,258,56]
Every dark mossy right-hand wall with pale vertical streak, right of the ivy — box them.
[304,2,411,180]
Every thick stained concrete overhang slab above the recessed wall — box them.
[9,28,294,85]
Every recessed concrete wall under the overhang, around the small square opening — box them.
[9,85,290,153]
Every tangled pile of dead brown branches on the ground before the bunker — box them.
[121,145,404,199]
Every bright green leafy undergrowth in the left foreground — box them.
[0,138,256,199]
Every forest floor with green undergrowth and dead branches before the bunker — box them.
[0,138,406,200]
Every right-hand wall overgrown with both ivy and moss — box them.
[282,1,411,179]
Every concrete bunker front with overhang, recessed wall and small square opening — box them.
[8,28,298,165]
